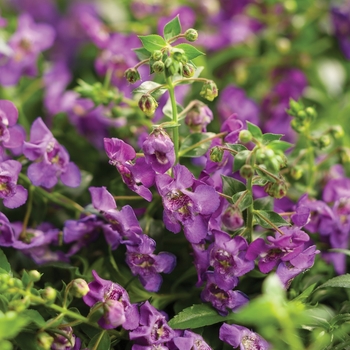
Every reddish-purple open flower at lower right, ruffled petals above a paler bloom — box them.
[246,227,310,273]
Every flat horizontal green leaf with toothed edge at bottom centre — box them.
[168,304,230,329]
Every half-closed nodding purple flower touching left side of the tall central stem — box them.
[142,128,175,174]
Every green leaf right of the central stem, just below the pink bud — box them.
[179,132,215,158]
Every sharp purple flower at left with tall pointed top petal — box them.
[23,117,81,188]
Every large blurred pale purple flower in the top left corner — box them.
[0,14,55,86]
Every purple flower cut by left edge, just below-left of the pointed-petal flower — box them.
[0,160,28,209]
